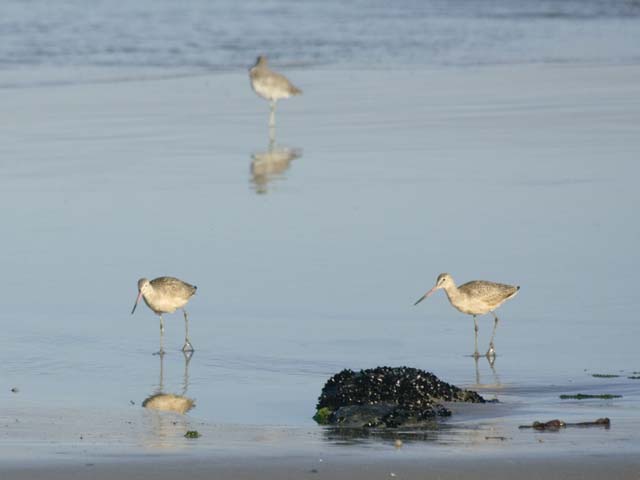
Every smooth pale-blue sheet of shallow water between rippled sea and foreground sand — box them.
[0,62,640,448]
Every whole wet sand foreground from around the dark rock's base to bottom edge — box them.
[0,376,640,480]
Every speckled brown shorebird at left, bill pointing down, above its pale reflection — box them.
[131,277,198,355]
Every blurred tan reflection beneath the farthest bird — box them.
[251,127,302,194]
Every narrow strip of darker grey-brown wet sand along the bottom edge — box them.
[2,454,640,480]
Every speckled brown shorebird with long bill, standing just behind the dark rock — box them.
[414,273,520,358]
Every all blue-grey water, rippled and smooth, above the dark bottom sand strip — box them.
[0,0,640,458]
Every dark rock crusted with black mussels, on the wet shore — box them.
[314,367,485,428]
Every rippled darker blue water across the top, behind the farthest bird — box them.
[0,0,640,86]
